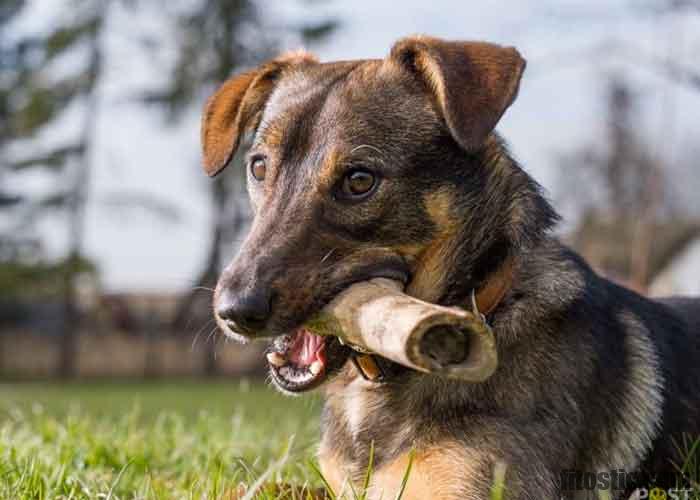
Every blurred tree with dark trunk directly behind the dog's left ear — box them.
[143,0,336,374]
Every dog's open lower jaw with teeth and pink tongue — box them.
[266,327,351,394]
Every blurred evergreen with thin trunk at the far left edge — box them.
[0,0,110,376]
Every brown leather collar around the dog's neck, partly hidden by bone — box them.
[350,257,514,383]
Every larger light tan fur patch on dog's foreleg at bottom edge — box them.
[369,443,480,500]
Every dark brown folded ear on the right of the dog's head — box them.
[390,36,525,151]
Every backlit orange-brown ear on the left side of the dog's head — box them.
[202,51,317,177]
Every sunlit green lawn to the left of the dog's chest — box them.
[0,381,321,500]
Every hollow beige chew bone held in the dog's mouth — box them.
[305,278,498,382]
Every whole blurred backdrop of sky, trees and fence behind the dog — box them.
[0,0,700,380]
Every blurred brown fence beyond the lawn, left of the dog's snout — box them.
[0,286,263,378]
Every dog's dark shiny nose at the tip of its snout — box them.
[216,290,271,335]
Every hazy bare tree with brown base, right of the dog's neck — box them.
[562,76,700,291]
